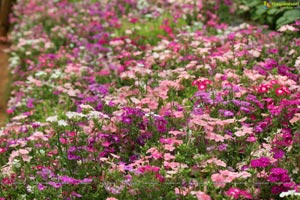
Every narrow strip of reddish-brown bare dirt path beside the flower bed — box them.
[0,43,9,127]
